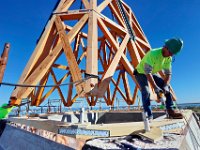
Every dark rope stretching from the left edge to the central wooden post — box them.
[0,74,98,87]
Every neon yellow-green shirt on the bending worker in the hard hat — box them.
[136,48,172,74]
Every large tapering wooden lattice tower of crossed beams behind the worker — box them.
[11,0,174,106]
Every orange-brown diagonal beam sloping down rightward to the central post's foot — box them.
[55,16,84,95]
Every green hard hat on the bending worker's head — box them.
[165,38,183,55]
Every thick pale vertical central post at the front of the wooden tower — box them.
[84,0,98,95]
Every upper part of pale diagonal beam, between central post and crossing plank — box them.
[67,14,88,43]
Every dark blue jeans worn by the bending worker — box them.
[135,73,173,118]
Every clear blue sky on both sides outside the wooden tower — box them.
[0,0,200,104]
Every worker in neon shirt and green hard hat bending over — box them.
[134,38,183,120]
